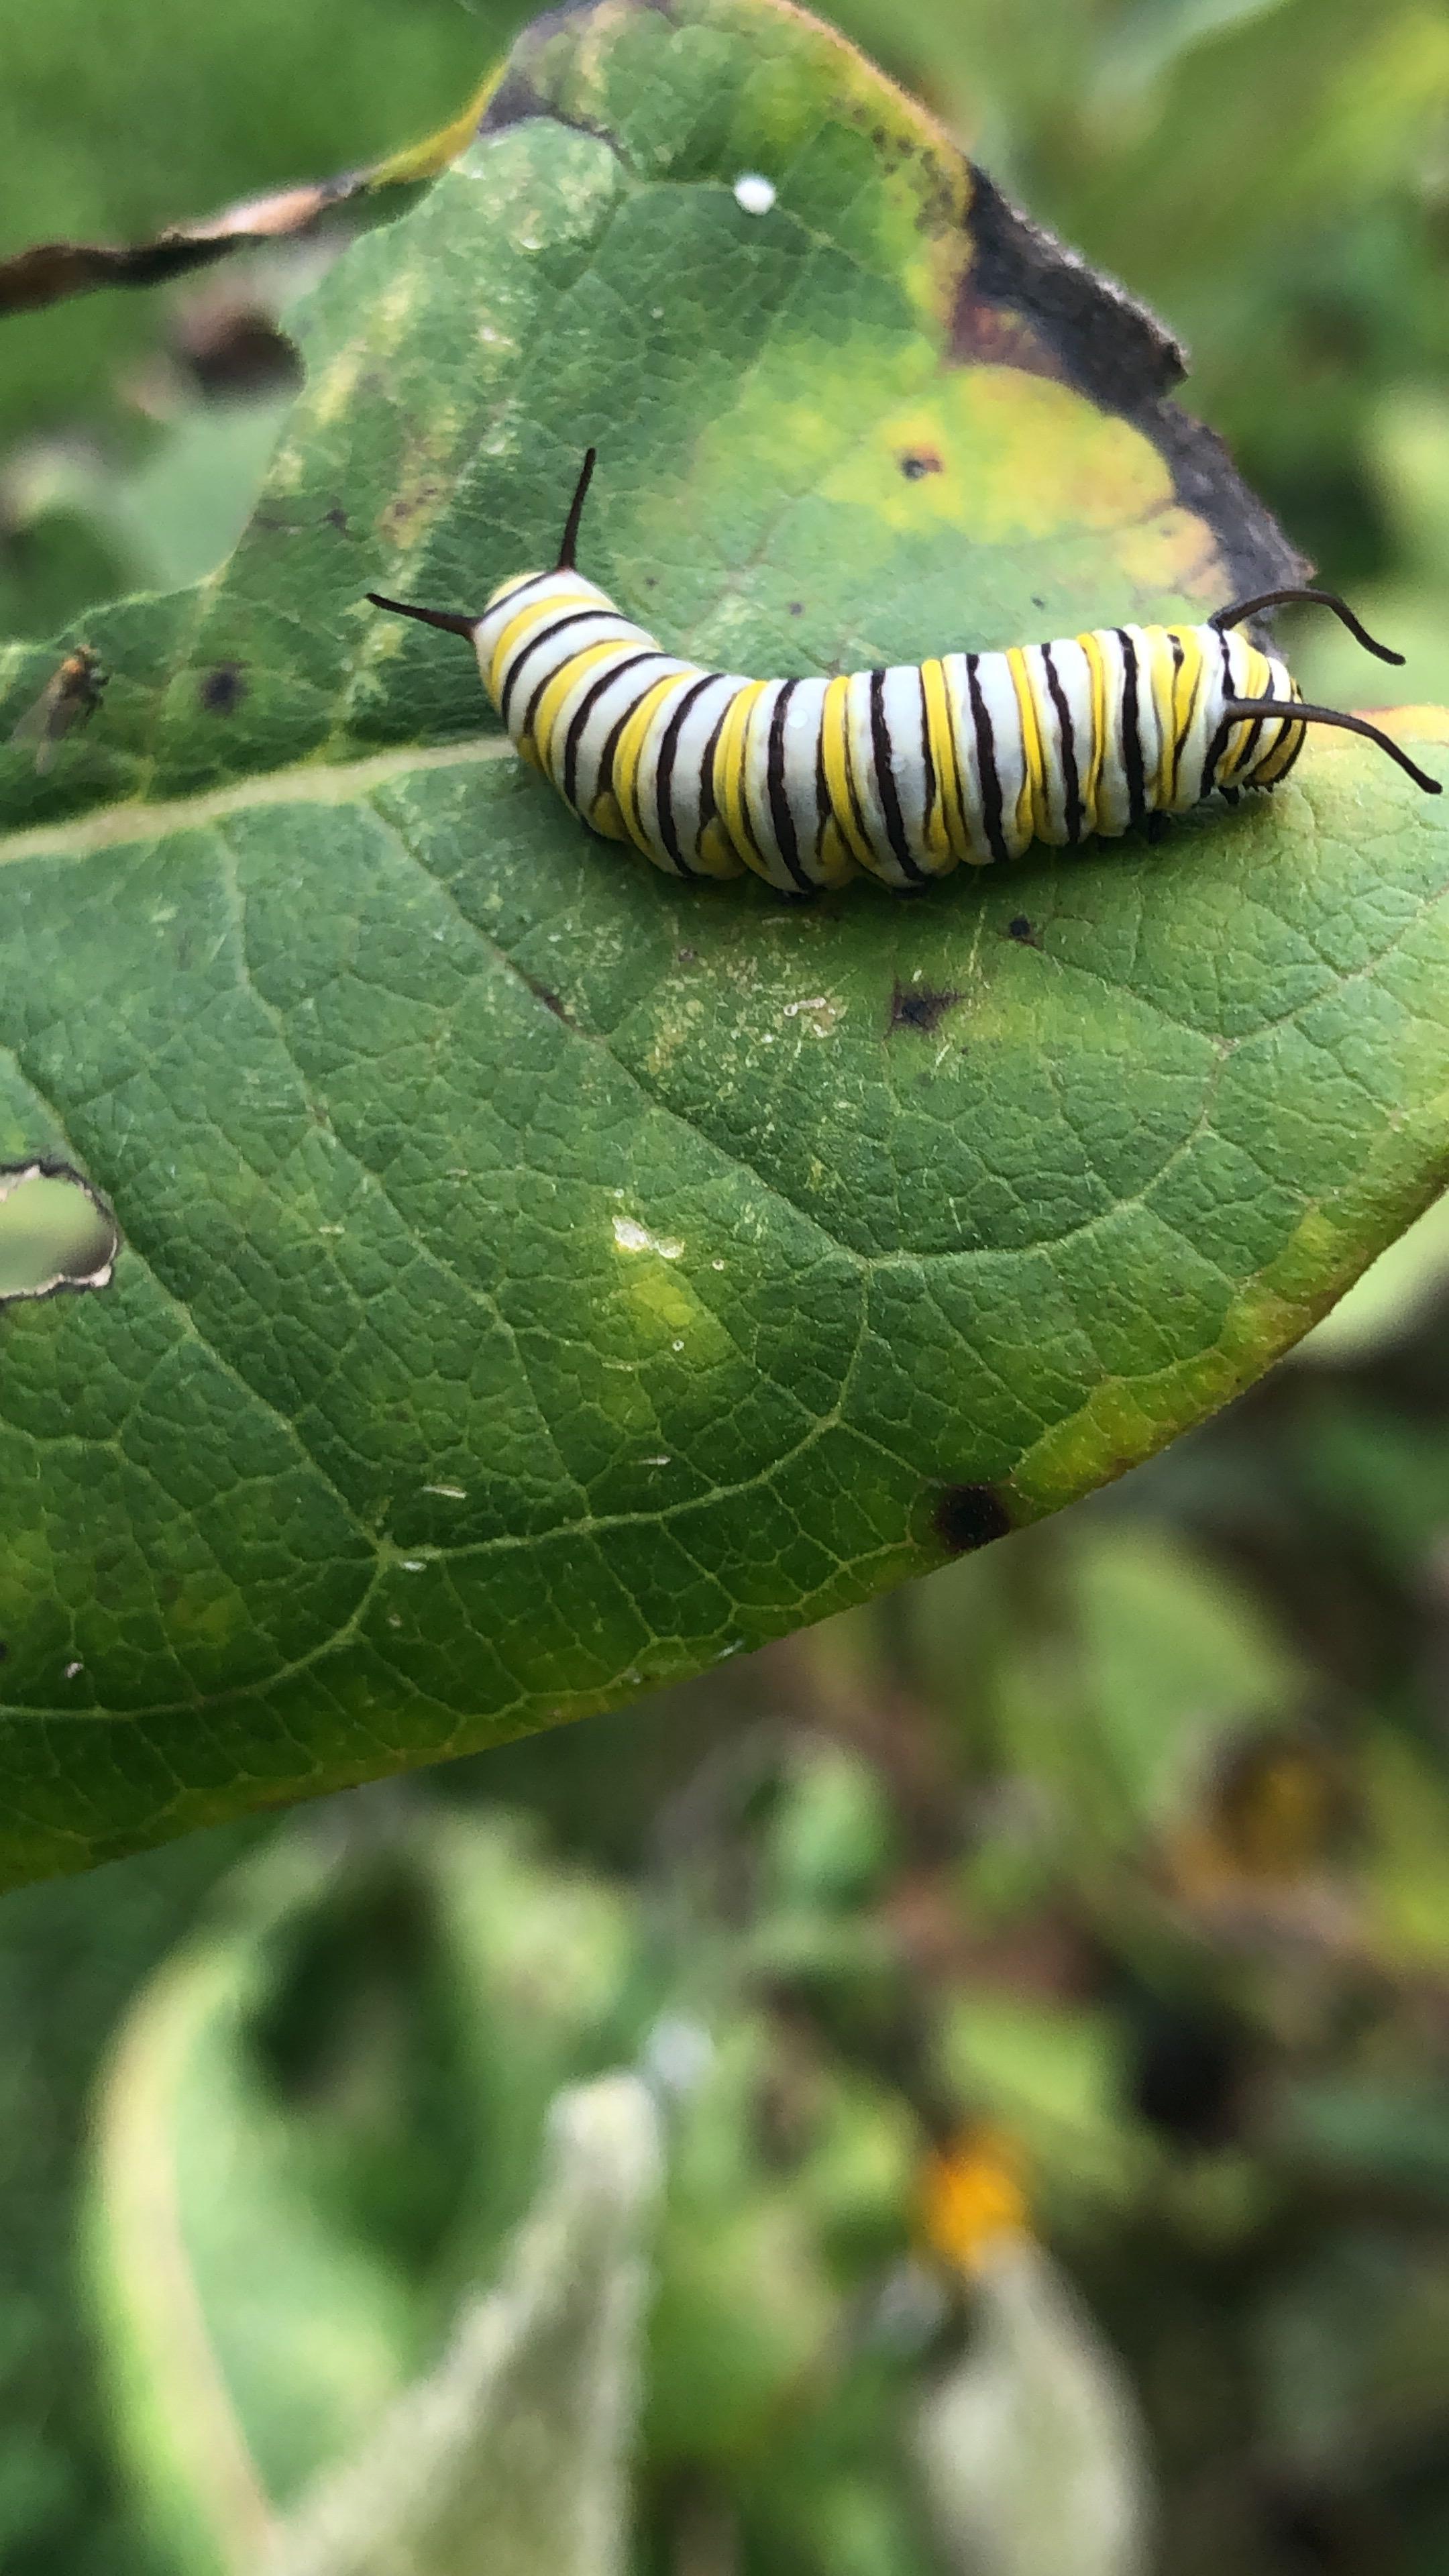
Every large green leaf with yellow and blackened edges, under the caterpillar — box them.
[0,0,1449,1878]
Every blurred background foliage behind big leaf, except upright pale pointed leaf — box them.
[0,0,1449,2576]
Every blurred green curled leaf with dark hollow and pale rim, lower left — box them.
[88,1816,632,2576]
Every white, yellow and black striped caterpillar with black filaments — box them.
[369,448,1439,894]
